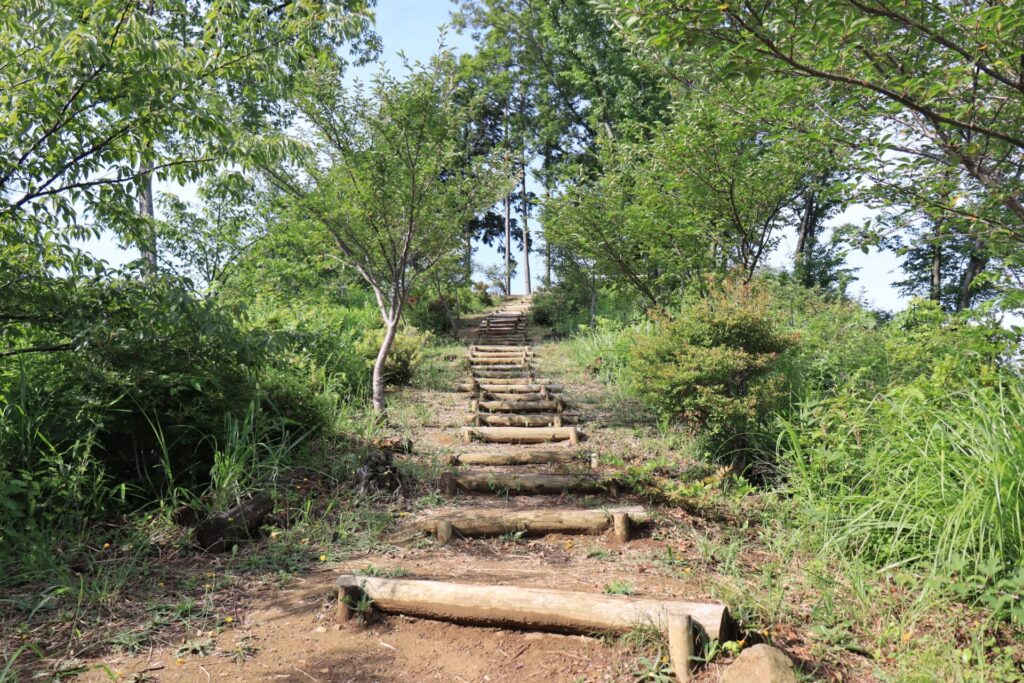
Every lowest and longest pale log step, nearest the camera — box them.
[335,574,733,640]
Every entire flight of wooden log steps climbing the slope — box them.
[337,296,731,681]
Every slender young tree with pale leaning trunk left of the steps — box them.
[267,52,510,414]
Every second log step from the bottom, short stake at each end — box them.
[419,505,650,541]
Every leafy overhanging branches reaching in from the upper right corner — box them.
[602,0,1024,304]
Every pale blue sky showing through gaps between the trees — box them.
[83,0,906,310]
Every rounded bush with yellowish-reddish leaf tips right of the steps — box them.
[630,281,796,460]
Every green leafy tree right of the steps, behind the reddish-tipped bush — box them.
[545,82,837,304]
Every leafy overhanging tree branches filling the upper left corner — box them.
[0,0,375,354]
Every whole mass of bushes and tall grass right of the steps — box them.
[541,275,1024,680]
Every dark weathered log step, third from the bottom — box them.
[440,471,620,496]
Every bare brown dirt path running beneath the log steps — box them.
[74,306,774,683]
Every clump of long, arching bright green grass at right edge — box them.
[779,377,1024,573]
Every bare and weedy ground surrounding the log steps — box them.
[2,311,991,682]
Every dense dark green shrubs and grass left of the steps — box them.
[0,262,480,586]
